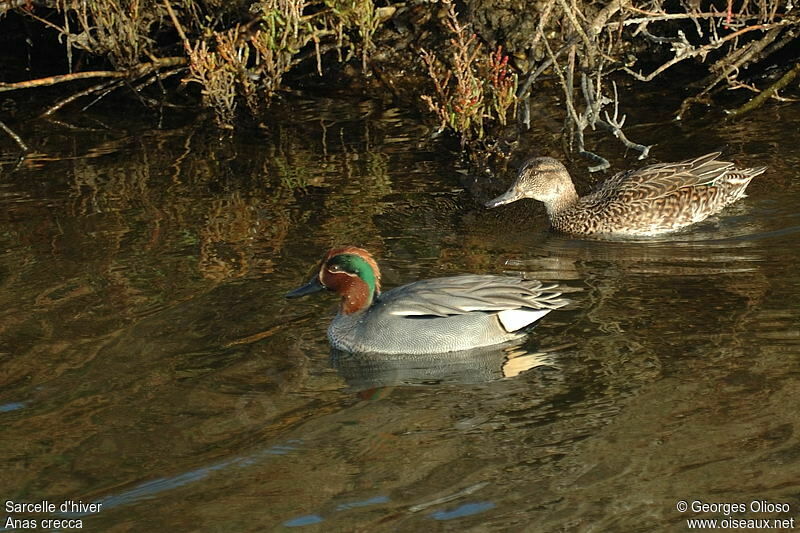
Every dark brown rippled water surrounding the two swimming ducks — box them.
[0,96,800,532]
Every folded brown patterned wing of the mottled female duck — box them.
[595,152,733,200]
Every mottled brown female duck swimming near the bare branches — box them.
[486,152,767,236]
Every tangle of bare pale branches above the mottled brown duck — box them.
[517,0,800,166]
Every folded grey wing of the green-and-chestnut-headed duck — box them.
[378,274,569,317]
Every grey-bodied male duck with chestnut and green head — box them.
[286,246,568,354]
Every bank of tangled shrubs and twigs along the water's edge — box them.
[0,0,800,164]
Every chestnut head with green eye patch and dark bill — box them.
[286,246,381,314]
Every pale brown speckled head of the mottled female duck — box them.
[486,157,578,211]
